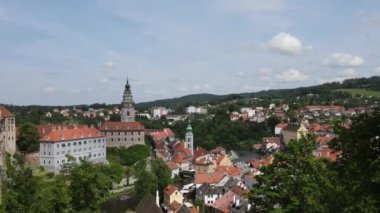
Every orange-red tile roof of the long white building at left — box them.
[40,128,104,142]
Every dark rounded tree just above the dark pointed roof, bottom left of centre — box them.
[135,170,158,201]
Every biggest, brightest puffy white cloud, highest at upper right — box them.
[266,32,312,55]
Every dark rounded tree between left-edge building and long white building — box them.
[17,122,39,152]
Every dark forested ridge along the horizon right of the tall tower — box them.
[137,76,380,108]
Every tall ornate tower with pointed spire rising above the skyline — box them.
[120,78,135,122]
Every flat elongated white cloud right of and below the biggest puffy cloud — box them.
[322,53,364,67]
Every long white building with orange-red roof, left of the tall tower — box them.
[40,127,106,174]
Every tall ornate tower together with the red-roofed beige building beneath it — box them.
[100,79,145,147]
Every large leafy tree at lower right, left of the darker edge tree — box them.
[250,137,331,212]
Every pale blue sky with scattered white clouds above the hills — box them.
[0,0,380,105]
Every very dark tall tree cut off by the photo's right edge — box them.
[330,109,380,212]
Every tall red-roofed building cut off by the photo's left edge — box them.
[0,105,16,156]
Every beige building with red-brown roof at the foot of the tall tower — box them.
[100,121,145,147]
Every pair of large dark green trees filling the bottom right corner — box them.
[249,109,380,212]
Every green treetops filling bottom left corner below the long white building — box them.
[1,155,123,213]
